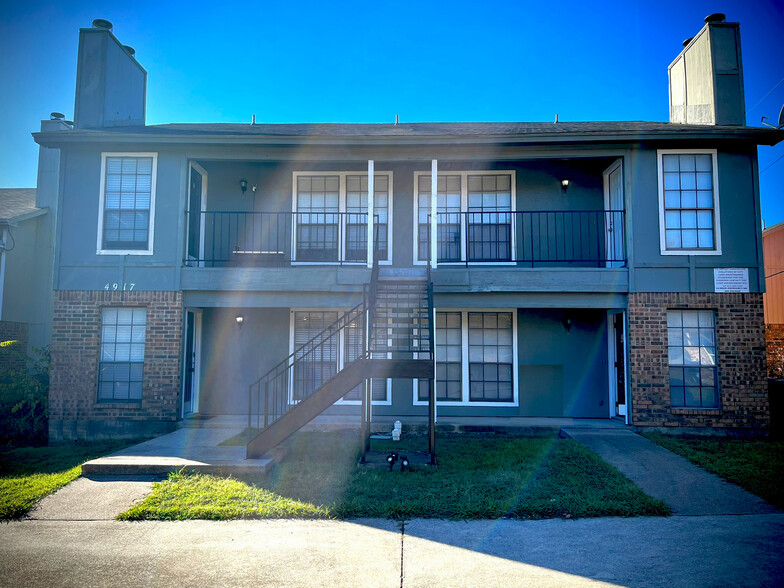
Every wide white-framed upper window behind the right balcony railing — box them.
[415,171,515,263]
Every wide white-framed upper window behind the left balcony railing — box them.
[293,172,392,263]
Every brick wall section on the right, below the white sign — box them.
[629,292,770,429]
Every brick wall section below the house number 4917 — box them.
[49,290,182,440]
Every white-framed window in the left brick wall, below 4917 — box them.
[98,308,147,402]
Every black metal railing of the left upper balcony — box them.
[184,211,380,267]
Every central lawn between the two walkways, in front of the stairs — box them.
[120,432,670,520]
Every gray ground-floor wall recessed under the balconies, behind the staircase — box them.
[194,308,609,418]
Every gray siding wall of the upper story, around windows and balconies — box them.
[55,145,763,292]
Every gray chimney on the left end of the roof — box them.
[74,19,147,129]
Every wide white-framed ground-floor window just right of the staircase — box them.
[415,311,517,404]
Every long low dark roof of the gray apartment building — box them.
[34,121,784,145]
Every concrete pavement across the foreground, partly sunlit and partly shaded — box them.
[0,514,784,588]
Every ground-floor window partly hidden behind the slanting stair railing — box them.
[291,310,390,404]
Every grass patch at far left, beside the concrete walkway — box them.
[0,441,143,520]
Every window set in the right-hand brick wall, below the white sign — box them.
[667,310,719,408]
